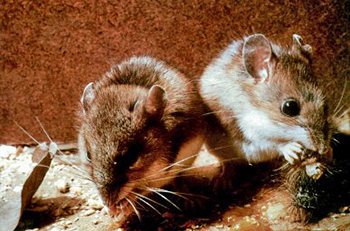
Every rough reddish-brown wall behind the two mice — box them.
[0,0,350,144]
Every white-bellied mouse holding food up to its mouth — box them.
[198,34,333,185]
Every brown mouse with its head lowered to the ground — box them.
[78,56,204,223]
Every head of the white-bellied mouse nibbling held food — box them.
[242,34,331,161]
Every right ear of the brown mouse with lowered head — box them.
[145,85,167,120]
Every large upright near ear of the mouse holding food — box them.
[242,34,273,82]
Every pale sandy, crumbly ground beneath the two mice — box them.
[0,143,350,231]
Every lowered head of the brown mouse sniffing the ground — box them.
[79,83,176,218]
